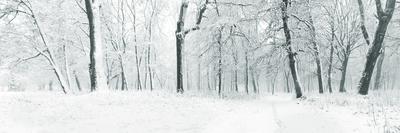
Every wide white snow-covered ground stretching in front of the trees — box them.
[0,92,394,133]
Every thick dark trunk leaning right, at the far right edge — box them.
[358,0,396,95]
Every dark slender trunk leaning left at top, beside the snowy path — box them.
[281,0,303,98]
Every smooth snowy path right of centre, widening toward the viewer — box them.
[204,97,345,133]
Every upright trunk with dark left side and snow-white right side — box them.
[85,0,108,91]
